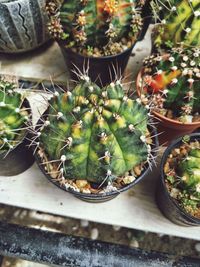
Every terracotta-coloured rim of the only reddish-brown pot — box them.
[135,67,200,127]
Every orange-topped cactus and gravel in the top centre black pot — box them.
[46,0,145,56]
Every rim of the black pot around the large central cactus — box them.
[34,116,159,200]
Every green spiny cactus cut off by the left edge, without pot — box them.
[0,78,29,155]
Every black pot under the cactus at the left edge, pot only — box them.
[0,99,35,176]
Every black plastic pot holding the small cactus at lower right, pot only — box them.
[156,133,200,226]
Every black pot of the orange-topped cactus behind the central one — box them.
[58,1,151,86]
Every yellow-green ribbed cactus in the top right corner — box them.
[152,0,200,48]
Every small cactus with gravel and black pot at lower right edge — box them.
[157,133,200,226]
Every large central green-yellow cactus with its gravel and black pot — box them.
[33,76,157,202]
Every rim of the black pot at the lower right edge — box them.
[160,133,200,224]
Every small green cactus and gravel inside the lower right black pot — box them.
[165,140,200,218]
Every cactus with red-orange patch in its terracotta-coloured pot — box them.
[136,48,200,146]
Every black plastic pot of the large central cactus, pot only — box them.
[35,124,158,203]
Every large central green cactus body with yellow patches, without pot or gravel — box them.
[39,81,149,183]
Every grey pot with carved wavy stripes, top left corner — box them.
[0,0,49,53]
